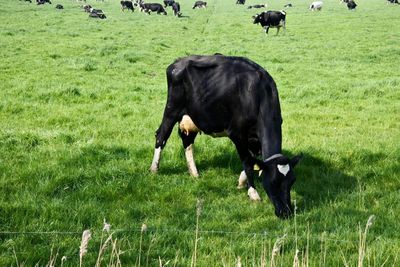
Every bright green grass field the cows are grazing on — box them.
[0,0,400,266]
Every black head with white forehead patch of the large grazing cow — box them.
[261,154,302,218]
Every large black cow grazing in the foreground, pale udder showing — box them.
[150,55,300,218]
